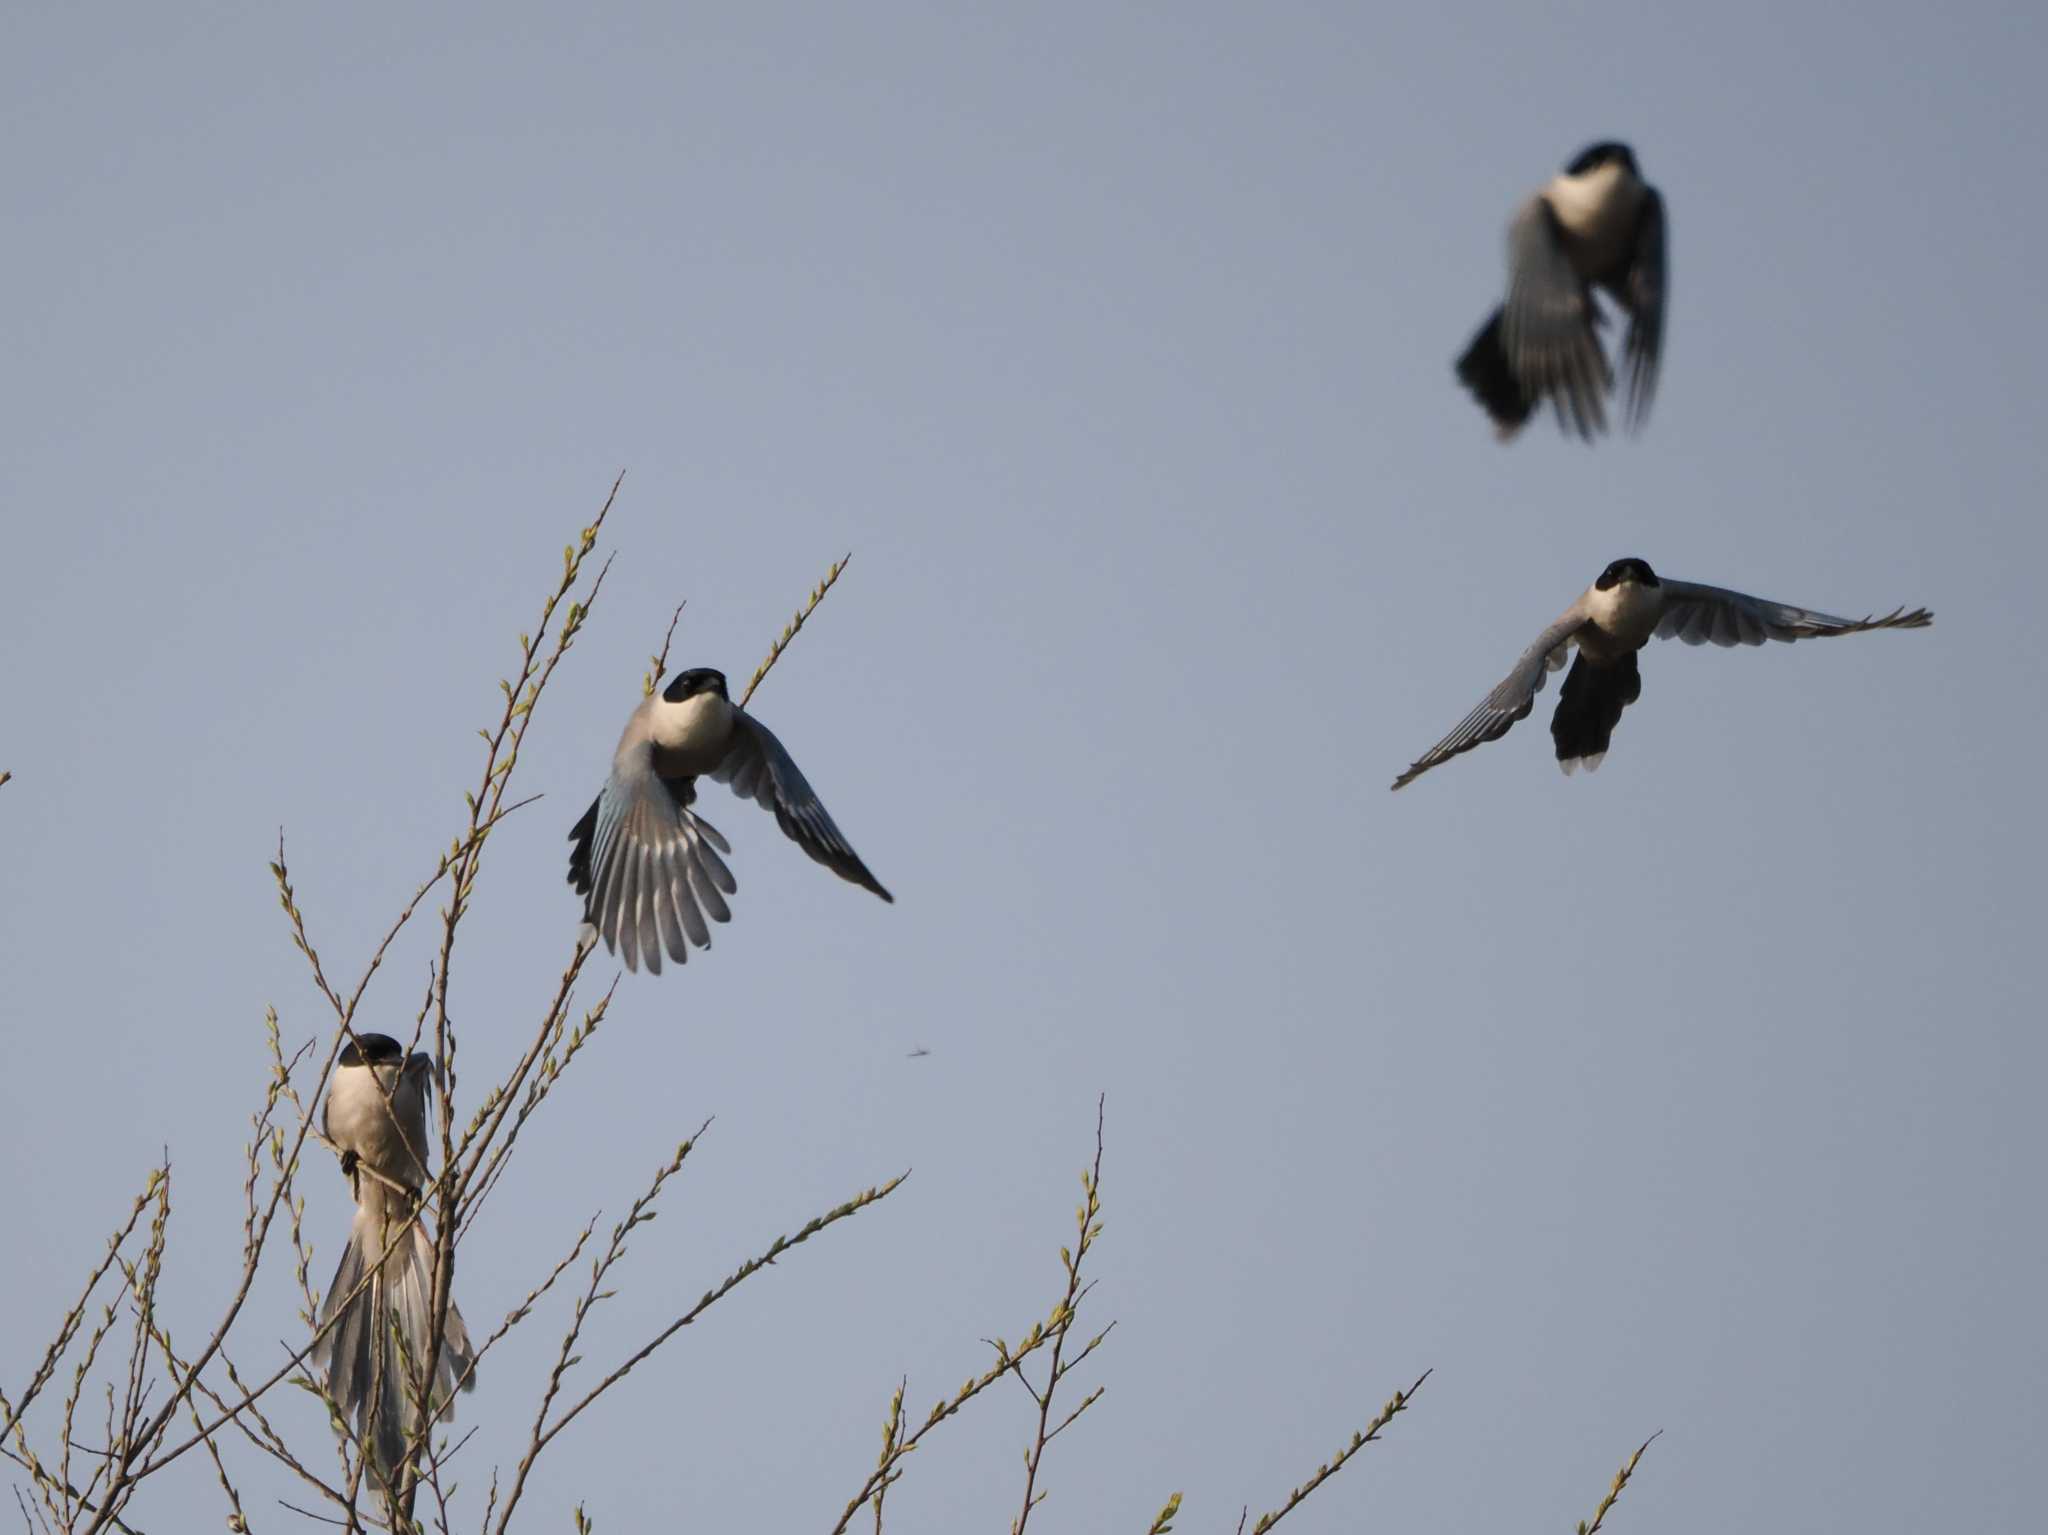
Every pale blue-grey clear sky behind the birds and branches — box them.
[0,4,2048,1535]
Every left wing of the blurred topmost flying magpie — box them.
[1501,196,1614,440]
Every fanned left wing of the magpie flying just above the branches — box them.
[569,743,739,974]
